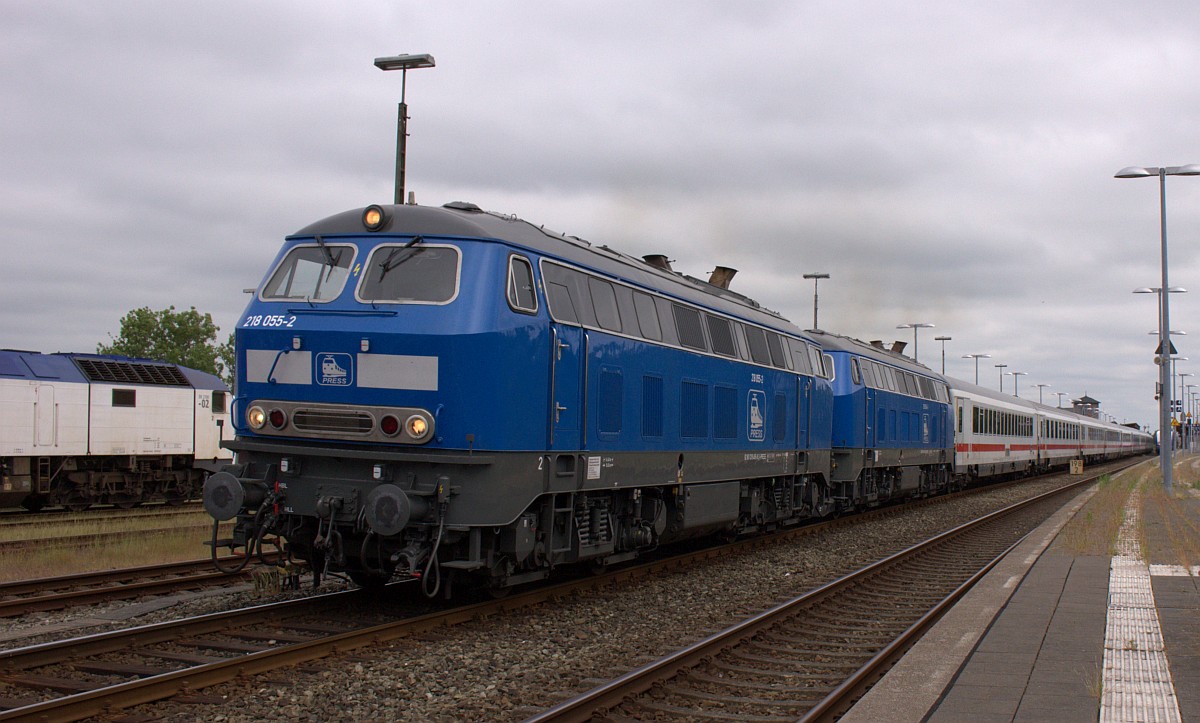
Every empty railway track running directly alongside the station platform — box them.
[529,463,1123,723]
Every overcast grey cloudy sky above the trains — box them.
[0,0,1200,426]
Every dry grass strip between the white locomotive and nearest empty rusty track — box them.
[0,509,226,581]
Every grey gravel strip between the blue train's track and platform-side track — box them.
[43,473,1089,722]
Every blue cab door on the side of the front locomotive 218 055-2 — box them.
[550,323,588,449]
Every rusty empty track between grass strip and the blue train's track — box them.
[0,557,272,617]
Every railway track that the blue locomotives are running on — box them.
[0,461,1132,721]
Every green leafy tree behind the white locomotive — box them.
[96,306,234,383]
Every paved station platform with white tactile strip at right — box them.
[841,458,1200,723]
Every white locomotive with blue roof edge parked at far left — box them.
[0,349,233,510]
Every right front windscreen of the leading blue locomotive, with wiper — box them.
[359,244,458,304]
